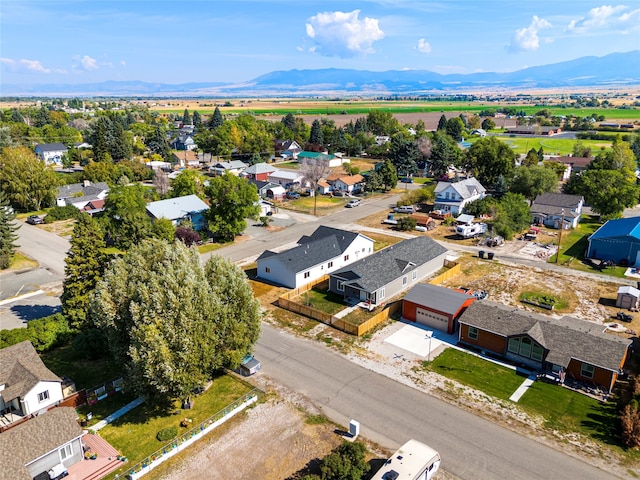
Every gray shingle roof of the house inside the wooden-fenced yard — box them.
[331,237,447,292]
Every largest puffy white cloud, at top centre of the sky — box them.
[306,10,384,58]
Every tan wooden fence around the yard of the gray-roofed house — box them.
[278,262,460,336]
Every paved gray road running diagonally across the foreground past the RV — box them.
[256,324,617,480]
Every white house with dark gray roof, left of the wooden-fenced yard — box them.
[257,226,374,288]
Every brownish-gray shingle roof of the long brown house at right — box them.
[459,301,631,371]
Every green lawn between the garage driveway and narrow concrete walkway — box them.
[424,348,527,400]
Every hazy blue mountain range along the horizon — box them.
[0,50,640,97]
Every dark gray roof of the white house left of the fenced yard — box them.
[258,226,360,273]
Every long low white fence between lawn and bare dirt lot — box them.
[127,388,262,480]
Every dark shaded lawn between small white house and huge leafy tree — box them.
[41,345,122,390]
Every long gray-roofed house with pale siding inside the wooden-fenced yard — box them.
[329,237,448,306]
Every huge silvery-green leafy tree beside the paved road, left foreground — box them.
[91,240,260,401]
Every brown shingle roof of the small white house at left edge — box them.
[0,340,62,404]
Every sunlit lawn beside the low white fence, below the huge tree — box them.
[100,375,251,470]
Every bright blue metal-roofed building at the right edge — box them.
[587,217,640,266]
